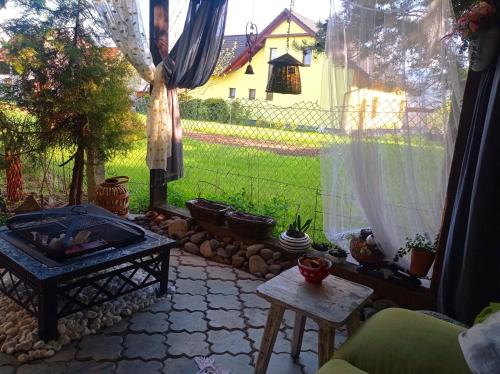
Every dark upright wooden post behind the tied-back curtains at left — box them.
[149,0,169,209]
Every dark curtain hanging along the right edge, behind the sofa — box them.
[438,51,500,324]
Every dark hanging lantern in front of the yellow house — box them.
[266,53,304,95]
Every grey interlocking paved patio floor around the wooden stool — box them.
[0,250,346,374]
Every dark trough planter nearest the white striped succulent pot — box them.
[226,211,276,239]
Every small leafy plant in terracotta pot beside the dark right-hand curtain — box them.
[394,234,438,277]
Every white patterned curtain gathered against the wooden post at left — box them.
[94,0,172,170]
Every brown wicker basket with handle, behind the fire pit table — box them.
[96,176,129,217]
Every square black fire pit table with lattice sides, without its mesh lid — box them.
[0,213,175,341]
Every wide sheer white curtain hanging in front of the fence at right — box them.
[321,0,462,259]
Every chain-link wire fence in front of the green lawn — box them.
[0,94,446,241]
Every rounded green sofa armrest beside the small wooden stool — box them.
[318,308,470,374]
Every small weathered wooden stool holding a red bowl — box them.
[255,266,373,374]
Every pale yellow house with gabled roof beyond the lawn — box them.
[189,9,406,131]
